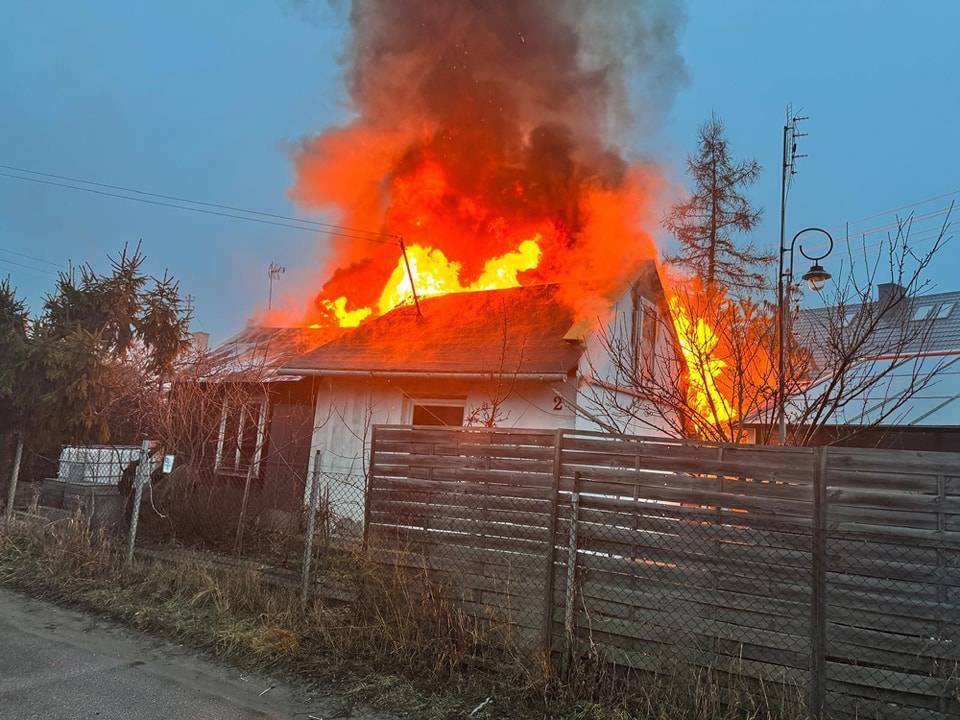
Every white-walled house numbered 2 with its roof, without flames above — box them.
[279,262,675,518]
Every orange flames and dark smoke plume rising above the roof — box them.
[274,0,682,326]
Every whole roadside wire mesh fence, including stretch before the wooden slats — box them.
[9,426,960,720]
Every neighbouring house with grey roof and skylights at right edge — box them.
[772,283,960,451]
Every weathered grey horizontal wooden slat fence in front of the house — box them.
[366,426,960,718]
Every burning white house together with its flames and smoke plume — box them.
[193,0,682,506]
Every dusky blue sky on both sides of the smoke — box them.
[0,0,960,339]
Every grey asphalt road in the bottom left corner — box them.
[0,590,388,720]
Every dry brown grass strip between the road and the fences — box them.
[0,518,805,720]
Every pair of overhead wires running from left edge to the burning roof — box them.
[0,165,397,245]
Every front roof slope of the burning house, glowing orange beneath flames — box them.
[284,285,583,375]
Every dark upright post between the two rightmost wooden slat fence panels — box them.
[810,447,827,720]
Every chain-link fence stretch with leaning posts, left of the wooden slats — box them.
[4,441,366,600]
